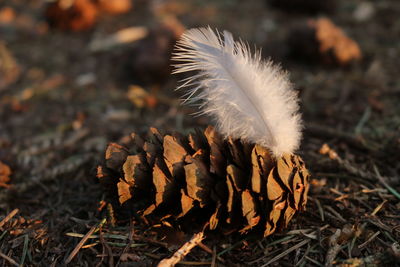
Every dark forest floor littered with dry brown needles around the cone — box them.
[0,0,400,266]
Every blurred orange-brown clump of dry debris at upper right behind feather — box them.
[289,18,362,66]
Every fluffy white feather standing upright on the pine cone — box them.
[172,28,302,157]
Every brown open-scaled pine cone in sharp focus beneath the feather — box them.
[97,127,309,236]
